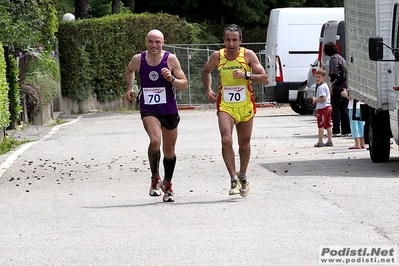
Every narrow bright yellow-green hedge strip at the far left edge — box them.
[0,43,10,129]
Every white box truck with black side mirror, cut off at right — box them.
[345,0,399,162]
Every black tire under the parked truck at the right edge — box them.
[368,109,391,163]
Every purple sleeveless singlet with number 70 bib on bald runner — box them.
[139,51,178,115]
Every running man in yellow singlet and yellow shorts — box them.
[202,24,269,197]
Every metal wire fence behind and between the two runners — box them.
[164,43,266,105]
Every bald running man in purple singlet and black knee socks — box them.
[125,30,188,202]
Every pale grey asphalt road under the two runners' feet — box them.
[0,107,399,265]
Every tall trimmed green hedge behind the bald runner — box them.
[57,13,201,102]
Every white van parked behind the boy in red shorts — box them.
[264,7,344,113]
